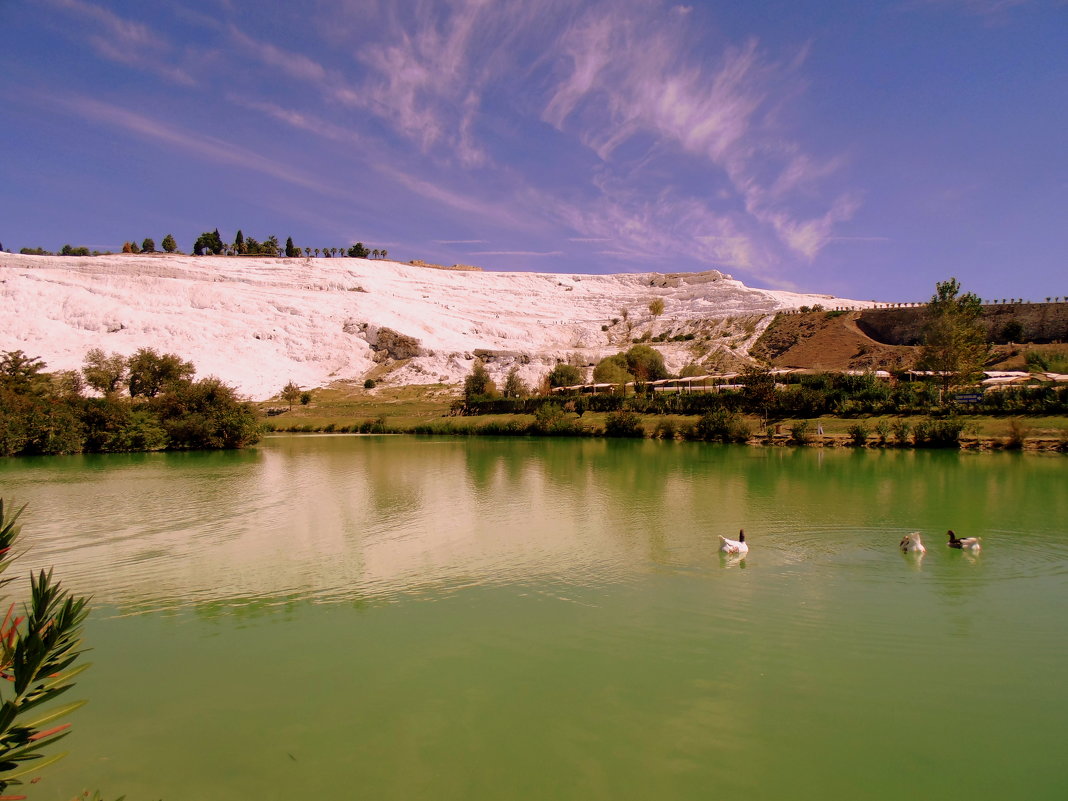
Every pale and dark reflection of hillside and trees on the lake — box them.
[0,437,1068,614]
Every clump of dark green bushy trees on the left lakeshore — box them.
[0,348,260,456]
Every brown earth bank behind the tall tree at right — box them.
[750,303,1068,371]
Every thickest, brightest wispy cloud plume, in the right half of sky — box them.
[543,4,859,264]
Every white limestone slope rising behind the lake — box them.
[0,253,869,399]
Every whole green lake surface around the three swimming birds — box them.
[0,437,1068,801]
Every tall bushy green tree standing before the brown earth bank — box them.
[918,278,990,392]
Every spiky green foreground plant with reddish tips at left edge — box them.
[0,499,89,801]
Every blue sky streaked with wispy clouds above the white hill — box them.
[0,0,1068,300]
